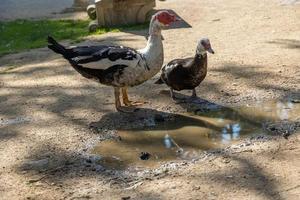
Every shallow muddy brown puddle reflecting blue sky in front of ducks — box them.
[92,101,300,169]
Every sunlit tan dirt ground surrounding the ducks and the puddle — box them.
[0,0,300,200]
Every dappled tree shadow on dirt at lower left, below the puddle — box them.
[16,144,115,183]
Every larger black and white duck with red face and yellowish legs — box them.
[48,11,179,112]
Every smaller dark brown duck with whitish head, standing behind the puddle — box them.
[155,38,214,100]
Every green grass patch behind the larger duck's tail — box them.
[0,20,148,56]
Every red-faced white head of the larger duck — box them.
[150,10,180,34]
